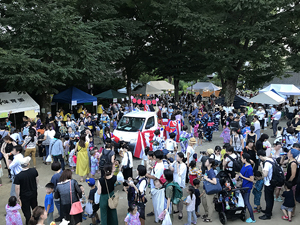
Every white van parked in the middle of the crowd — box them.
[113,111,158,150]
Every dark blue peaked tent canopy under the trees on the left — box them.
[52,87,97,104]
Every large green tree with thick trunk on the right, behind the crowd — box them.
[202,0,298,104]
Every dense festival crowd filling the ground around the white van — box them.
[0,94,300,225]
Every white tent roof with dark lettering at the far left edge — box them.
[0,91,40,113]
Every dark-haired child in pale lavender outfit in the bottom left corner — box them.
[5,196,23,225]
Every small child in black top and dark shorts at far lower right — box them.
[281,181,295,222]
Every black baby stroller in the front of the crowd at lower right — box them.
[214,171,249,224]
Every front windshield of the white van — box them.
[117,116,146,132]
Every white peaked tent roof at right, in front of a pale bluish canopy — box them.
[247,91,285,105]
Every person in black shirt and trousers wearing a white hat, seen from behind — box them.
[14,156,39,224]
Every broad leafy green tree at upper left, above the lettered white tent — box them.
[0,0,121,118]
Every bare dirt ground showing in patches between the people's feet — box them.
[0,121,300,225]
